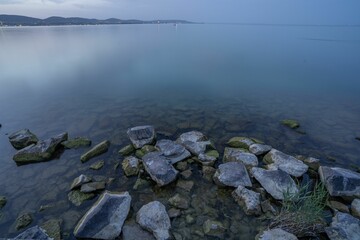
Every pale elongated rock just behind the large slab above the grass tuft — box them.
[263,149,309,177]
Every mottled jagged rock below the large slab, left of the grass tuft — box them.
[232,186,261,215]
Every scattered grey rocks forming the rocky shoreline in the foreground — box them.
[0,124,360,240]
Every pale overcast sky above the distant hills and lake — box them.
[0,0,360,24]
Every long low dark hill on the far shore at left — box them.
[0,14,192,26]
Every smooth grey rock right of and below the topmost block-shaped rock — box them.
[156,139,191,164]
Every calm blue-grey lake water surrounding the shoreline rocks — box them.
[0,25,360,239]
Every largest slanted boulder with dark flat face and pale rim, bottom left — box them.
[74,191,131,239]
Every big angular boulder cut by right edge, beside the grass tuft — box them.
[319,166,360,197]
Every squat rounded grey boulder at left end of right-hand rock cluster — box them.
[213,162,252,187]
